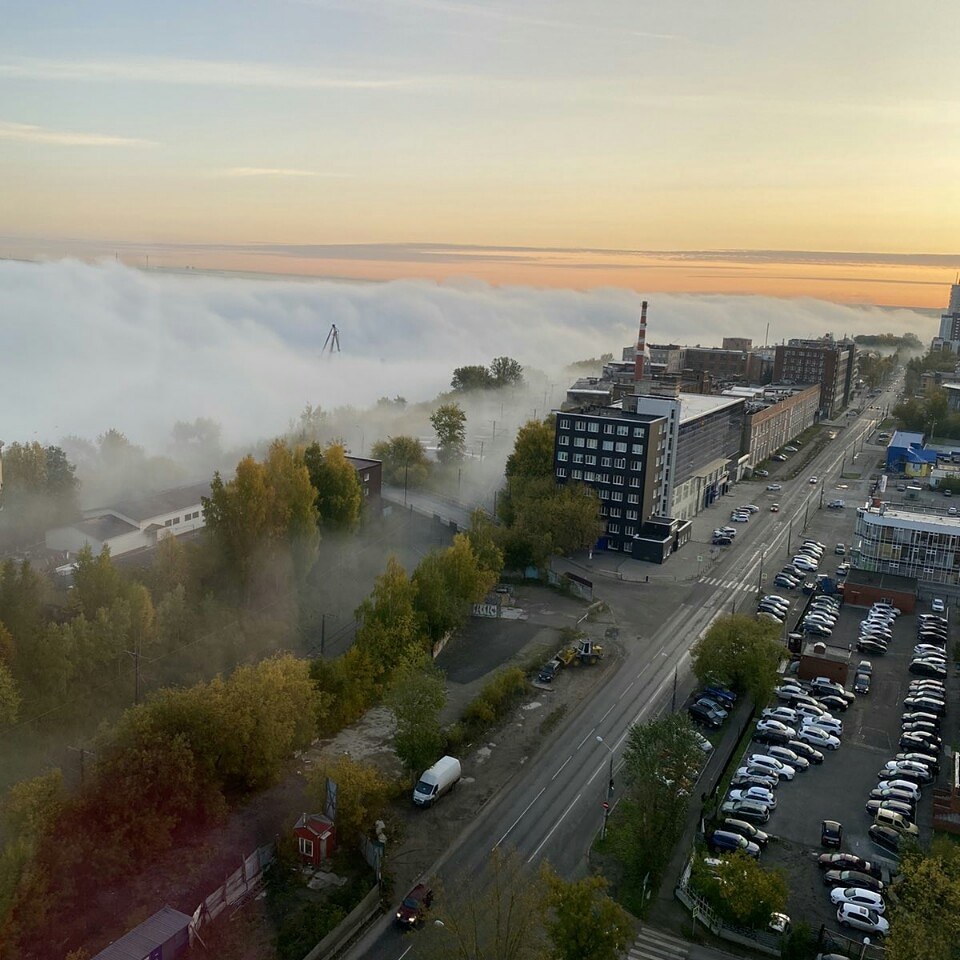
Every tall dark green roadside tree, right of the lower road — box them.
[609,714,703,910]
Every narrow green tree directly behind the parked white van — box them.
[386,650,447,774]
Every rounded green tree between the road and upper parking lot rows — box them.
[691,614,783,704]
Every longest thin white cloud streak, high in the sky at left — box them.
[0,57,432,90]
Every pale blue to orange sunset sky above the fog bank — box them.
[0,0,960,308]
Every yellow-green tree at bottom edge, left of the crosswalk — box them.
[542,866,634,960]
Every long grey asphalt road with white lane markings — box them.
[347,384,890,960]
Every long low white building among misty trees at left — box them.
[45,480,210,557]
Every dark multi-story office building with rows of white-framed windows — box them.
[554,406,676,559]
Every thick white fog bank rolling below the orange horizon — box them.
[0,255,934,452]
